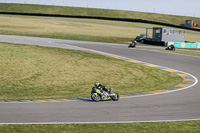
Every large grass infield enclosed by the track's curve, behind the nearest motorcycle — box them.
[0,43,182,100]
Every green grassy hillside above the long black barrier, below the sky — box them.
[0,3,200,28]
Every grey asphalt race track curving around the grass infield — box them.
[0,35,200,124]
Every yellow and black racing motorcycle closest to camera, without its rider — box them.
[91,87,119,102]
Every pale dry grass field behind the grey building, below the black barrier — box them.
[0,15,200,44]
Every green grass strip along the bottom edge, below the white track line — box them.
[0,121,200,133]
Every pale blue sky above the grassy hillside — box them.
[0,0,200,18]
